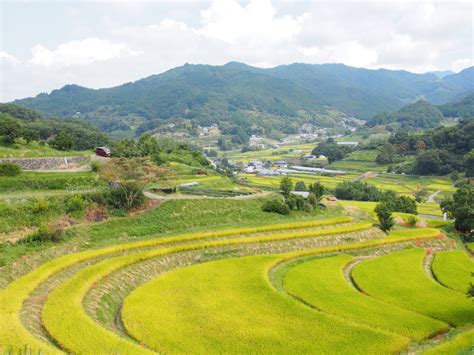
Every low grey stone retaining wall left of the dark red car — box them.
[0,156,88,170]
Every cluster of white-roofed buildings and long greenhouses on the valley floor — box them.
[241,159,346,176]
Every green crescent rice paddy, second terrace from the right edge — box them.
[352,248,474,326]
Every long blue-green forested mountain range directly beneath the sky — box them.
[12,62,474,136]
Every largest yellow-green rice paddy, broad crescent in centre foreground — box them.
[122,256,407,354]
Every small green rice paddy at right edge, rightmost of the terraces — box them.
[432,250,474,293]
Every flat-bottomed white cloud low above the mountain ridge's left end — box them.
[29,38,141,67]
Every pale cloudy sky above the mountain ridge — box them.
[0,0,474,102]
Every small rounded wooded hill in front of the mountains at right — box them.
[367,100,443,130]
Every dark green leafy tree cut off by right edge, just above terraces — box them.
[441,185,474,233]
